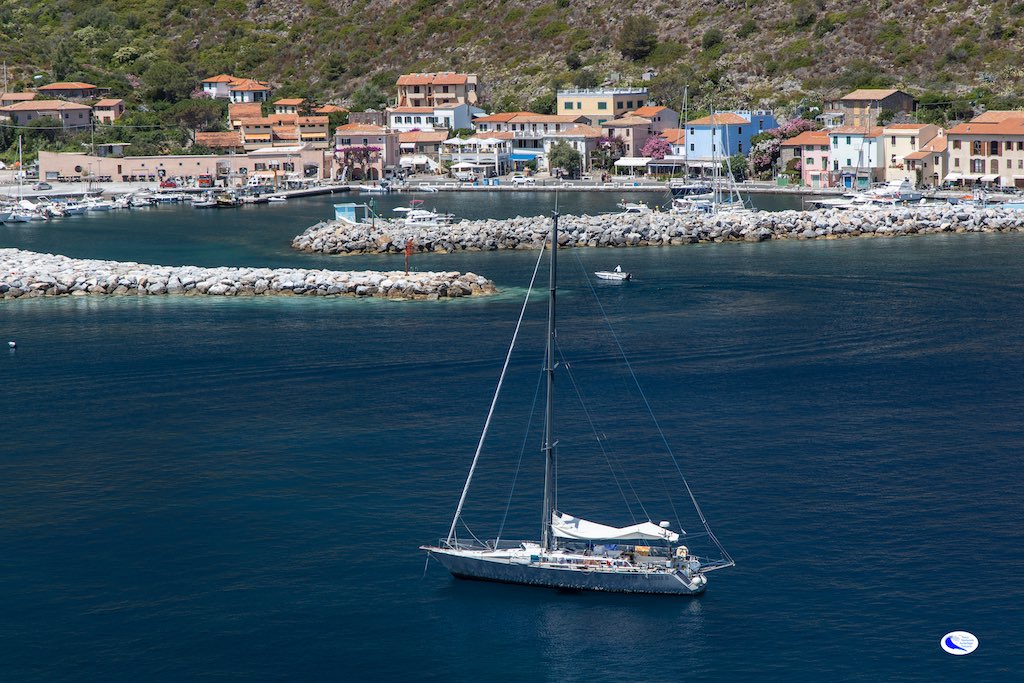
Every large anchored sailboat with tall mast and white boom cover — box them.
[420,214,734,595]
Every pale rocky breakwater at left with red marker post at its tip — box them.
[0,249,495,299]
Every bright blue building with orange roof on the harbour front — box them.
[686,111,778,174]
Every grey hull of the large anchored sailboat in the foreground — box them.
[424,547,708,595]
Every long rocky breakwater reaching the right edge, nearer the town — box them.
[292,204,1024,254]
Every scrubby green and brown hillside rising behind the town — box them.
[0,0,1024,116]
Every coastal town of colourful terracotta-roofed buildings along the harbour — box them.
[6,72,1024,193]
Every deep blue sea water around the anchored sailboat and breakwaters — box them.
[0,196,1024,681]
